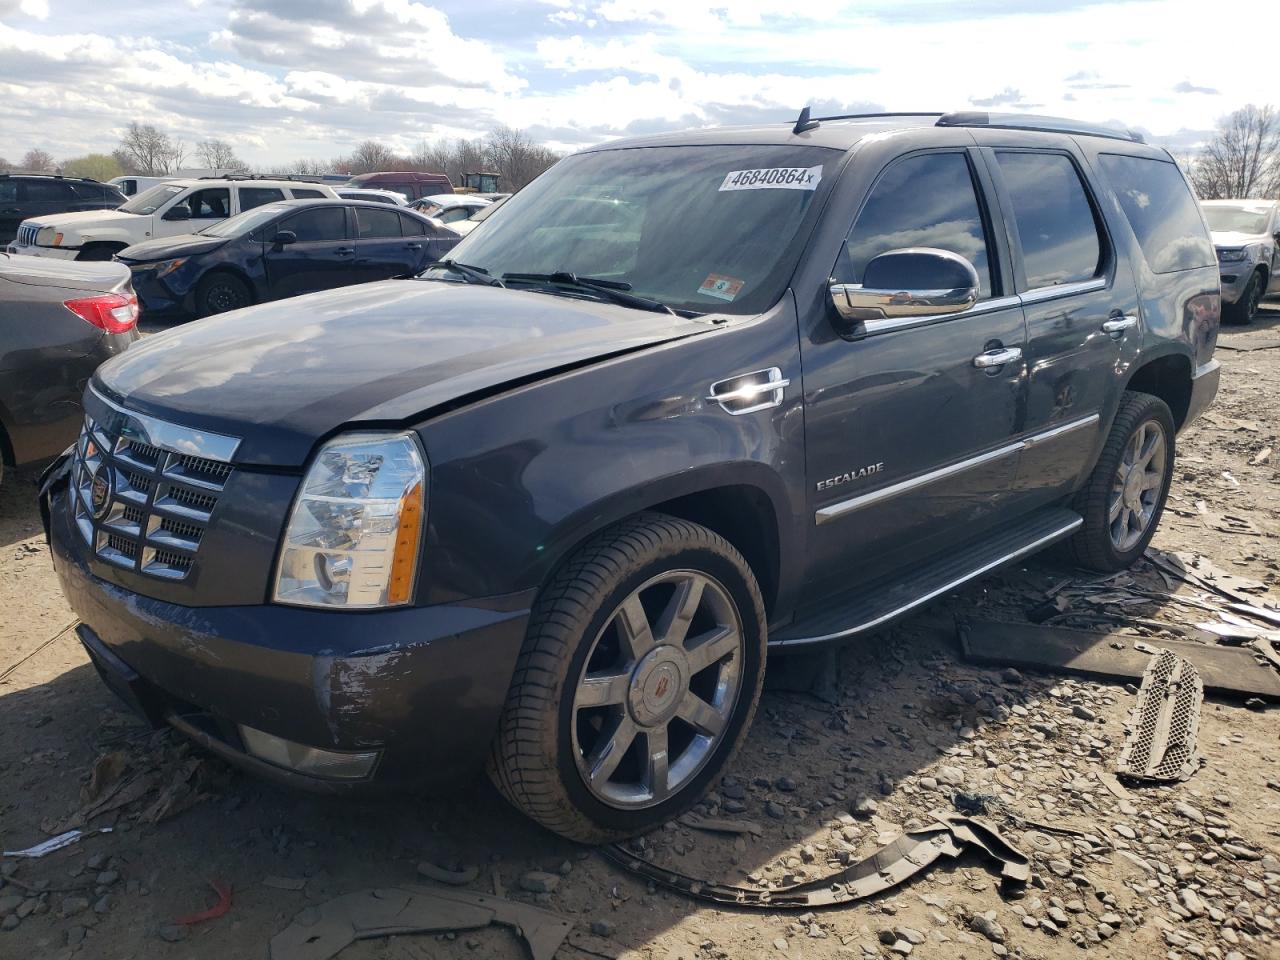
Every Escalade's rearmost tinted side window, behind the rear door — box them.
[1098,154,1217,274]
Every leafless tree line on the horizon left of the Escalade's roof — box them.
[0,123,561,191]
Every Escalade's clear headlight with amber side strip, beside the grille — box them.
[275,434,426,609]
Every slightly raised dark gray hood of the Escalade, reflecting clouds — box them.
[93,280,713,466]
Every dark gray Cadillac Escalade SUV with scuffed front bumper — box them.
[44,111,1220,841]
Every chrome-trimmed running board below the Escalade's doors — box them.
[769,507,1084,652]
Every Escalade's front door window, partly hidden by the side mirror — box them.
[835,154,993,297]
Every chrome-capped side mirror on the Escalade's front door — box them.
[831,247,978,323]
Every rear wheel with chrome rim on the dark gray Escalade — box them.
[1066,390,1174,572]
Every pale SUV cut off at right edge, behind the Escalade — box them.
[1201,200,1280,324]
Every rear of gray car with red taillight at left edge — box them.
[0,253,138,488]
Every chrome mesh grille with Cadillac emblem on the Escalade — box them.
[69,393,238,580]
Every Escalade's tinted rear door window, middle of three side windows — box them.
[996,151,1102,289]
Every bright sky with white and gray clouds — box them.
[0,0,1280,164]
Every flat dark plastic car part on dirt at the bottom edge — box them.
[271,887,572,960]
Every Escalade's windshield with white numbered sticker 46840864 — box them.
[449,145,841,314]
